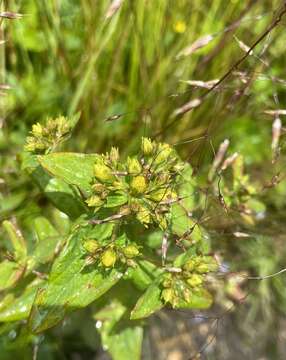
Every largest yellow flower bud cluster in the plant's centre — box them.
[86,138,184,229]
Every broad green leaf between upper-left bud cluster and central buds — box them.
[38,153,99,194]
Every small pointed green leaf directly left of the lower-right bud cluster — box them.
[130,282,164,320]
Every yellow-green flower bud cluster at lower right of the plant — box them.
[161,256,217,307]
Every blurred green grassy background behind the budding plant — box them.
[0,0,286,359]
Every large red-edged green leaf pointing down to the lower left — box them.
[29,224,122,333]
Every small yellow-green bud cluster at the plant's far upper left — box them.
[25,116,72,154]
